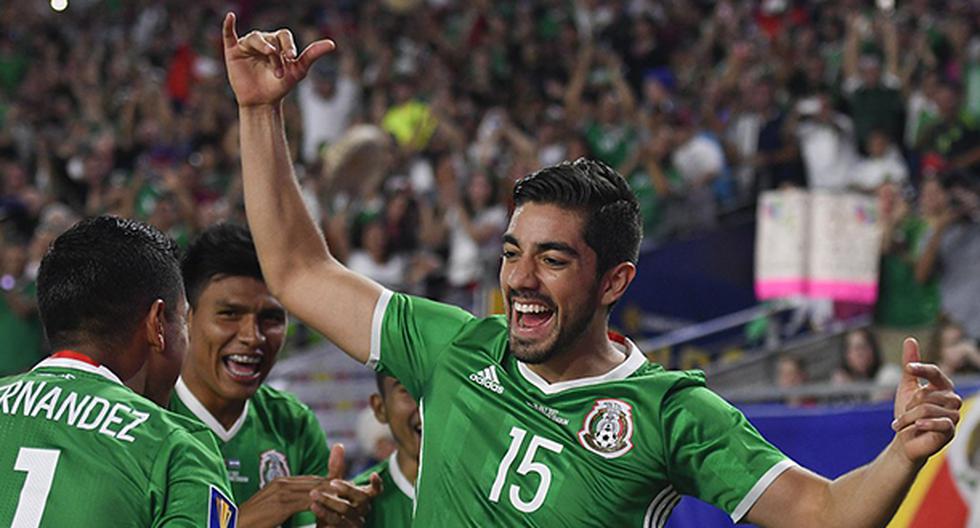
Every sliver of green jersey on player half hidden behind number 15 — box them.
[354,452,415,528]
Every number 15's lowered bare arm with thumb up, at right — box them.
[746,339,961,528]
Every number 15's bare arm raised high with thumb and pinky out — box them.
[223,13,382,363]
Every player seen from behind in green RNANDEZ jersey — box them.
[0,216,237,528]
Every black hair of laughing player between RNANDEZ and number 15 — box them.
[181,223,265,308]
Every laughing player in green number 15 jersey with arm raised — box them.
[223,14,960,527]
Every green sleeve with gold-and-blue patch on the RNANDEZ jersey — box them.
[150,430,238,528]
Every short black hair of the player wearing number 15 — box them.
[514,158,643,276]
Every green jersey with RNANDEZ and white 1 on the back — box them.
[0,357,237,528]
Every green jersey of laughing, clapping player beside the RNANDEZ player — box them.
[170,378,330,527]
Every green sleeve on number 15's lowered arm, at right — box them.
[661,387,793,522]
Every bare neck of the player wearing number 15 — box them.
[527,324,627,383]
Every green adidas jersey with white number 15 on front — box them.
[369,292,793,527]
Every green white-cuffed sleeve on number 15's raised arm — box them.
[368,291,474,399]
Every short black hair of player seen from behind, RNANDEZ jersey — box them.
[37,216,183,348]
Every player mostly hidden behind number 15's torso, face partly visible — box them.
[354,373,422,528]
